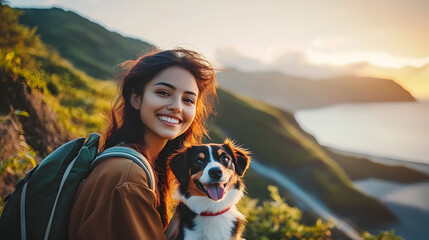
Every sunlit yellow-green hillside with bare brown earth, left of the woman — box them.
[0,8,116,156]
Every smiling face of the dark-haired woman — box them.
[131,67,199,142]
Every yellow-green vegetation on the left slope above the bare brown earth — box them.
[0,4,116,136]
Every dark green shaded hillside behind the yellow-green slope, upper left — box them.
[19,8,153,79]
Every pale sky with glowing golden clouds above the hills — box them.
[9,0,429,99]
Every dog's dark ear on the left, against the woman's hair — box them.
[169,148,189,185]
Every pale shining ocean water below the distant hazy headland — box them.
[294,102,429,164]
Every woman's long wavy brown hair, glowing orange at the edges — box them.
[101,48,217,227]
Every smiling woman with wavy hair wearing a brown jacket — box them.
[69,49,216,239]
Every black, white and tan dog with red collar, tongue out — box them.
[166,139,251,240]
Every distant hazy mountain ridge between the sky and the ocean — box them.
[218,71,415,112]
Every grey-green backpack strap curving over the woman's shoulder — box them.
[91,147,155,191]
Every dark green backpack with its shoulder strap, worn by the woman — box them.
[0,133,155,240]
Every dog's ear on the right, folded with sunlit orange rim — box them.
[223,138,251,177]
